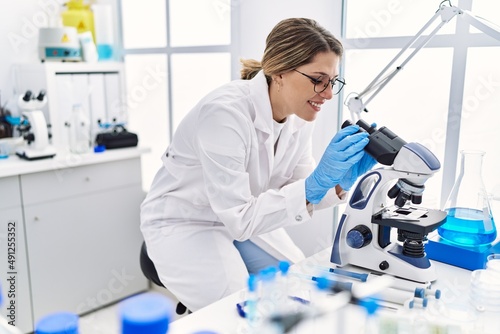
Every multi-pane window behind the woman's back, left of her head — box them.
[120,0,231,190]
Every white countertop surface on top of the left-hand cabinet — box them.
[0,147,150,178]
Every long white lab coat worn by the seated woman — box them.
[141,72,345,311]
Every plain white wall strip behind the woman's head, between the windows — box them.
[238,0,341,256]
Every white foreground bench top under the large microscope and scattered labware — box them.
[168,247,500,334]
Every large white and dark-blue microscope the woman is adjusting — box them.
[330,120,446,283]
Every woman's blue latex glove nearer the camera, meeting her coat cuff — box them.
[305,125,368,204]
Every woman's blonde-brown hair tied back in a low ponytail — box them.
[240,18,344,82]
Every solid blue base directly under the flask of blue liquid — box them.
[425,233,500,270]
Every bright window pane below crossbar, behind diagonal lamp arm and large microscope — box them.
[343,48,453,207]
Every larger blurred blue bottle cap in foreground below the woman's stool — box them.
[119,292,174,334]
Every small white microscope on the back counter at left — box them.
[16,90,56,160]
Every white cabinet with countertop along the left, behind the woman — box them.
[0,147,149,333]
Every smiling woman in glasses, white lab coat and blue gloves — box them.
[141,18,375,311]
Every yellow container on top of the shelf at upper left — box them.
[61,0,95,43]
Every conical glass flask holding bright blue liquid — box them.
[438,151,497,247]
